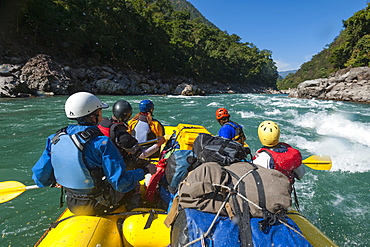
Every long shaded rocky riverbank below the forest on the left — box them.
[0,54,281,97]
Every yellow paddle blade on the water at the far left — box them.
[0,181,39,203]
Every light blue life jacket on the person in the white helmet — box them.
[51,128,103,189]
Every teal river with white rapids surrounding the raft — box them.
[0,94,370,247]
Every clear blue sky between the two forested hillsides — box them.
[188,0,367,71]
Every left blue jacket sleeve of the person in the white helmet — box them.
[32,137,55,187]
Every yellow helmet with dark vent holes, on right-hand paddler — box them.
[258,121,280,147]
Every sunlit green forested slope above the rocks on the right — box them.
[277,3,370,89]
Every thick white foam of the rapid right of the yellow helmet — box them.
[292,112,370,172]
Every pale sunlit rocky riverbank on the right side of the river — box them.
[289,67,370,103]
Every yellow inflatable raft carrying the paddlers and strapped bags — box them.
[35,124,336,247]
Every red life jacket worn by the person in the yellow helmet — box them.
[257,142,302,184]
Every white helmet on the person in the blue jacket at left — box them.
[64,92,109,119]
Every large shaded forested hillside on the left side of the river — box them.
[0,0,278,86]
